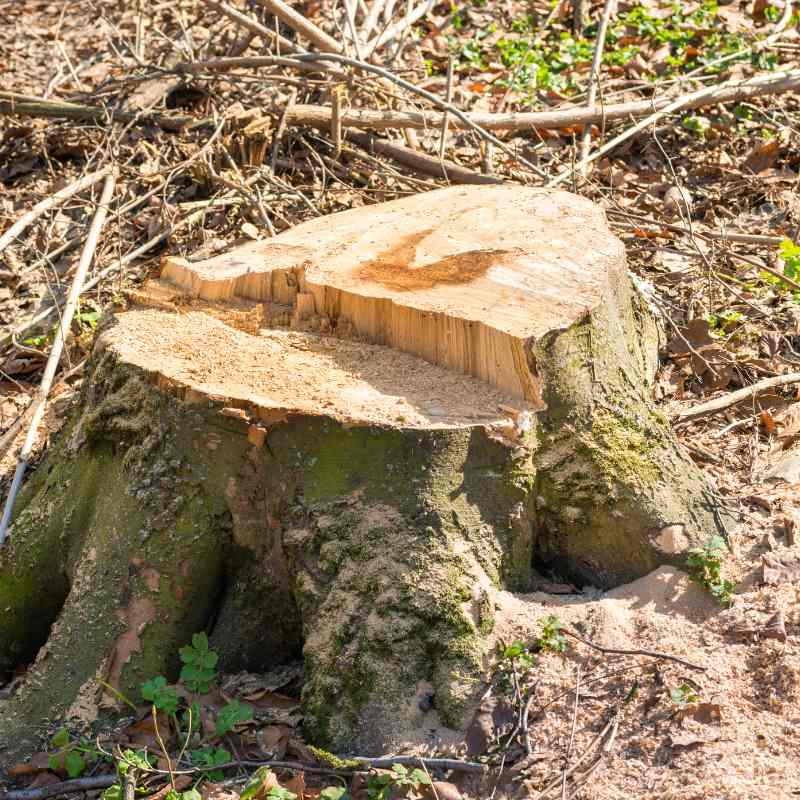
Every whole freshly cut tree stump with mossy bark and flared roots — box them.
[0,187,724,762]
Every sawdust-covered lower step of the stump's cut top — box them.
[106,308,519,428]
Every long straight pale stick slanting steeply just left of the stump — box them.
[0,173,116,546]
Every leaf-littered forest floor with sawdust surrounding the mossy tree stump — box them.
[0,0,800,800]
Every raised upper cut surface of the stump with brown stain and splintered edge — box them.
[155,186,625,407]
